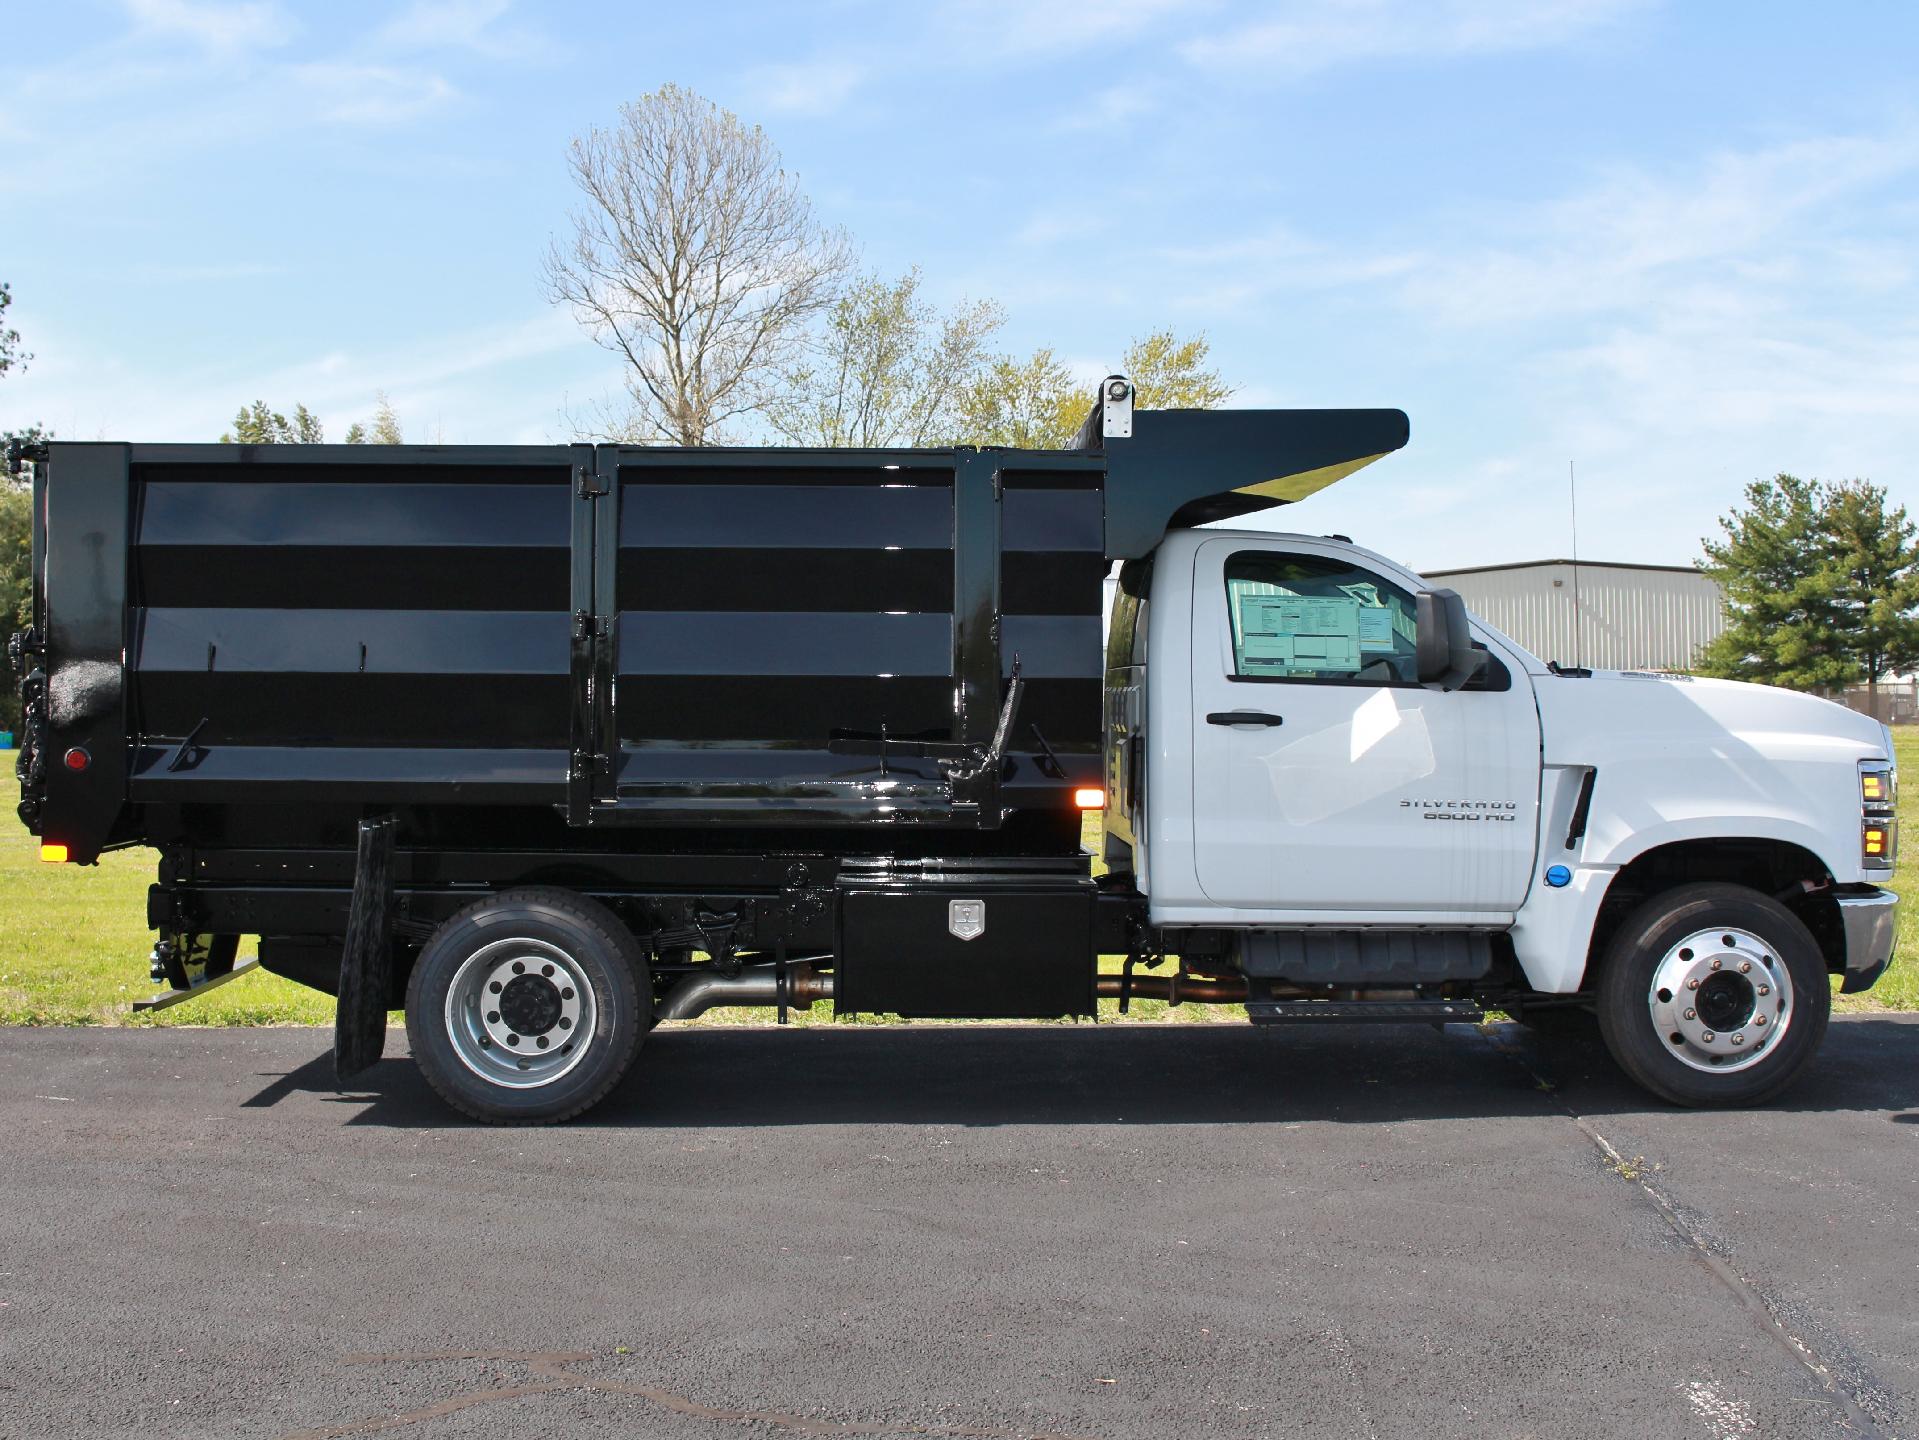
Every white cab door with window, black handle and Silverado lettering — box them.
[1192,538,1539,920]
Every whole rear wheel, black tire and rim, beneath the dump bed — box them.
[407,887,652,1125]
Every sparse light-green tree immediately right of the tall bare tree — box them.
[764,269,1006,445]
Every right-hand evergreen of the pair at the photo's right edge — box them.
[1819,480,1919,714]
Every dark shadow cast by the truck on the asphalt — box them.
[242,1018,1919,1129]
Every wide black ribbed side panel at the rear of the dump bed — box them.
[110,445,575,839]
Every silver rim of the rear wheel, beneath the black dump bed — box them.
[447,935,599,1091]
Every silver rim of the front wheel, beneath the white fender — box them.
[1647,927,1792,1075]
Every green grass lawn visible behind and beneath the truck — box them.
[0,744,1919,1025]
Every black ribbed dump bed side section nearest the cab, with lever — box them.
[593,449,1103,833]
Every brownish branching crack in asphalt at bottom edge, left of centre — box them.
[280,1350,1094,1440]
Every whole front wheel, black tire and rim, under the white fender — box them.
[1597,885,1833,1108]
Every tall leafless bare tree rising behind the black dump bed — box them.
[545,84,850,445]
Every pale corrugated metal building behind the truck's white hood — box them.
[1422,561,1725,670]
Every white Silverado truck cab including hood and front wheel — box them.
[1107,528,1896,1104]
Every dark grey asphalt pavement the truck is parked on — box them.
[0,1018,1919,1440]
